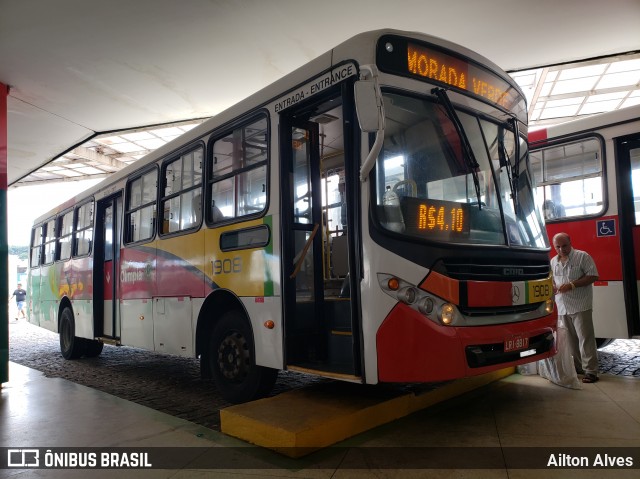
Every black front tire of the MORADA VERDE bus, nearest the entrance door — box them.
[207,310,278,404]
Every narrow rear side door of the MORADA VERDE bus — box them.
[94,196,122,342]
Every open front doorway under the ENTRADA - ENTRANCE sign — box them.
[281,99,361,381]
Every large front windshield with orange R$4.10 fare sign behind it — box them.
[375,92,548,248]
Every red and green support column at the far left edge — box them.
[0,83,9,385]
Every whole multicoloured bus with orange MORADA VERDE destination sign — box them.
[28,30,557,402]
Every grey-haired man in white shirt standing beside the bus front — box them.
[551,233,598,383]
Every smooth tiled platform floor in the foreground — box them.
[0,363,640,479]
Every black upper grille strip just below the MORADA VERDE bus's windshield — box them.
[442,258,550,281]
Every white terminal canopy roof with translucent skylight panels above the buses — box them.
[0,0,640,186]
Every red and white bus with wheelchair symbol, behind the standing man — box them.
[529,105,640,347]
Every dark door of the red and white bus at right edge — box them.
[616,134,640,337]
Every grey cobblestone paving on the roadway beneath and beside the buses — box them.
[9,320,640,431]
